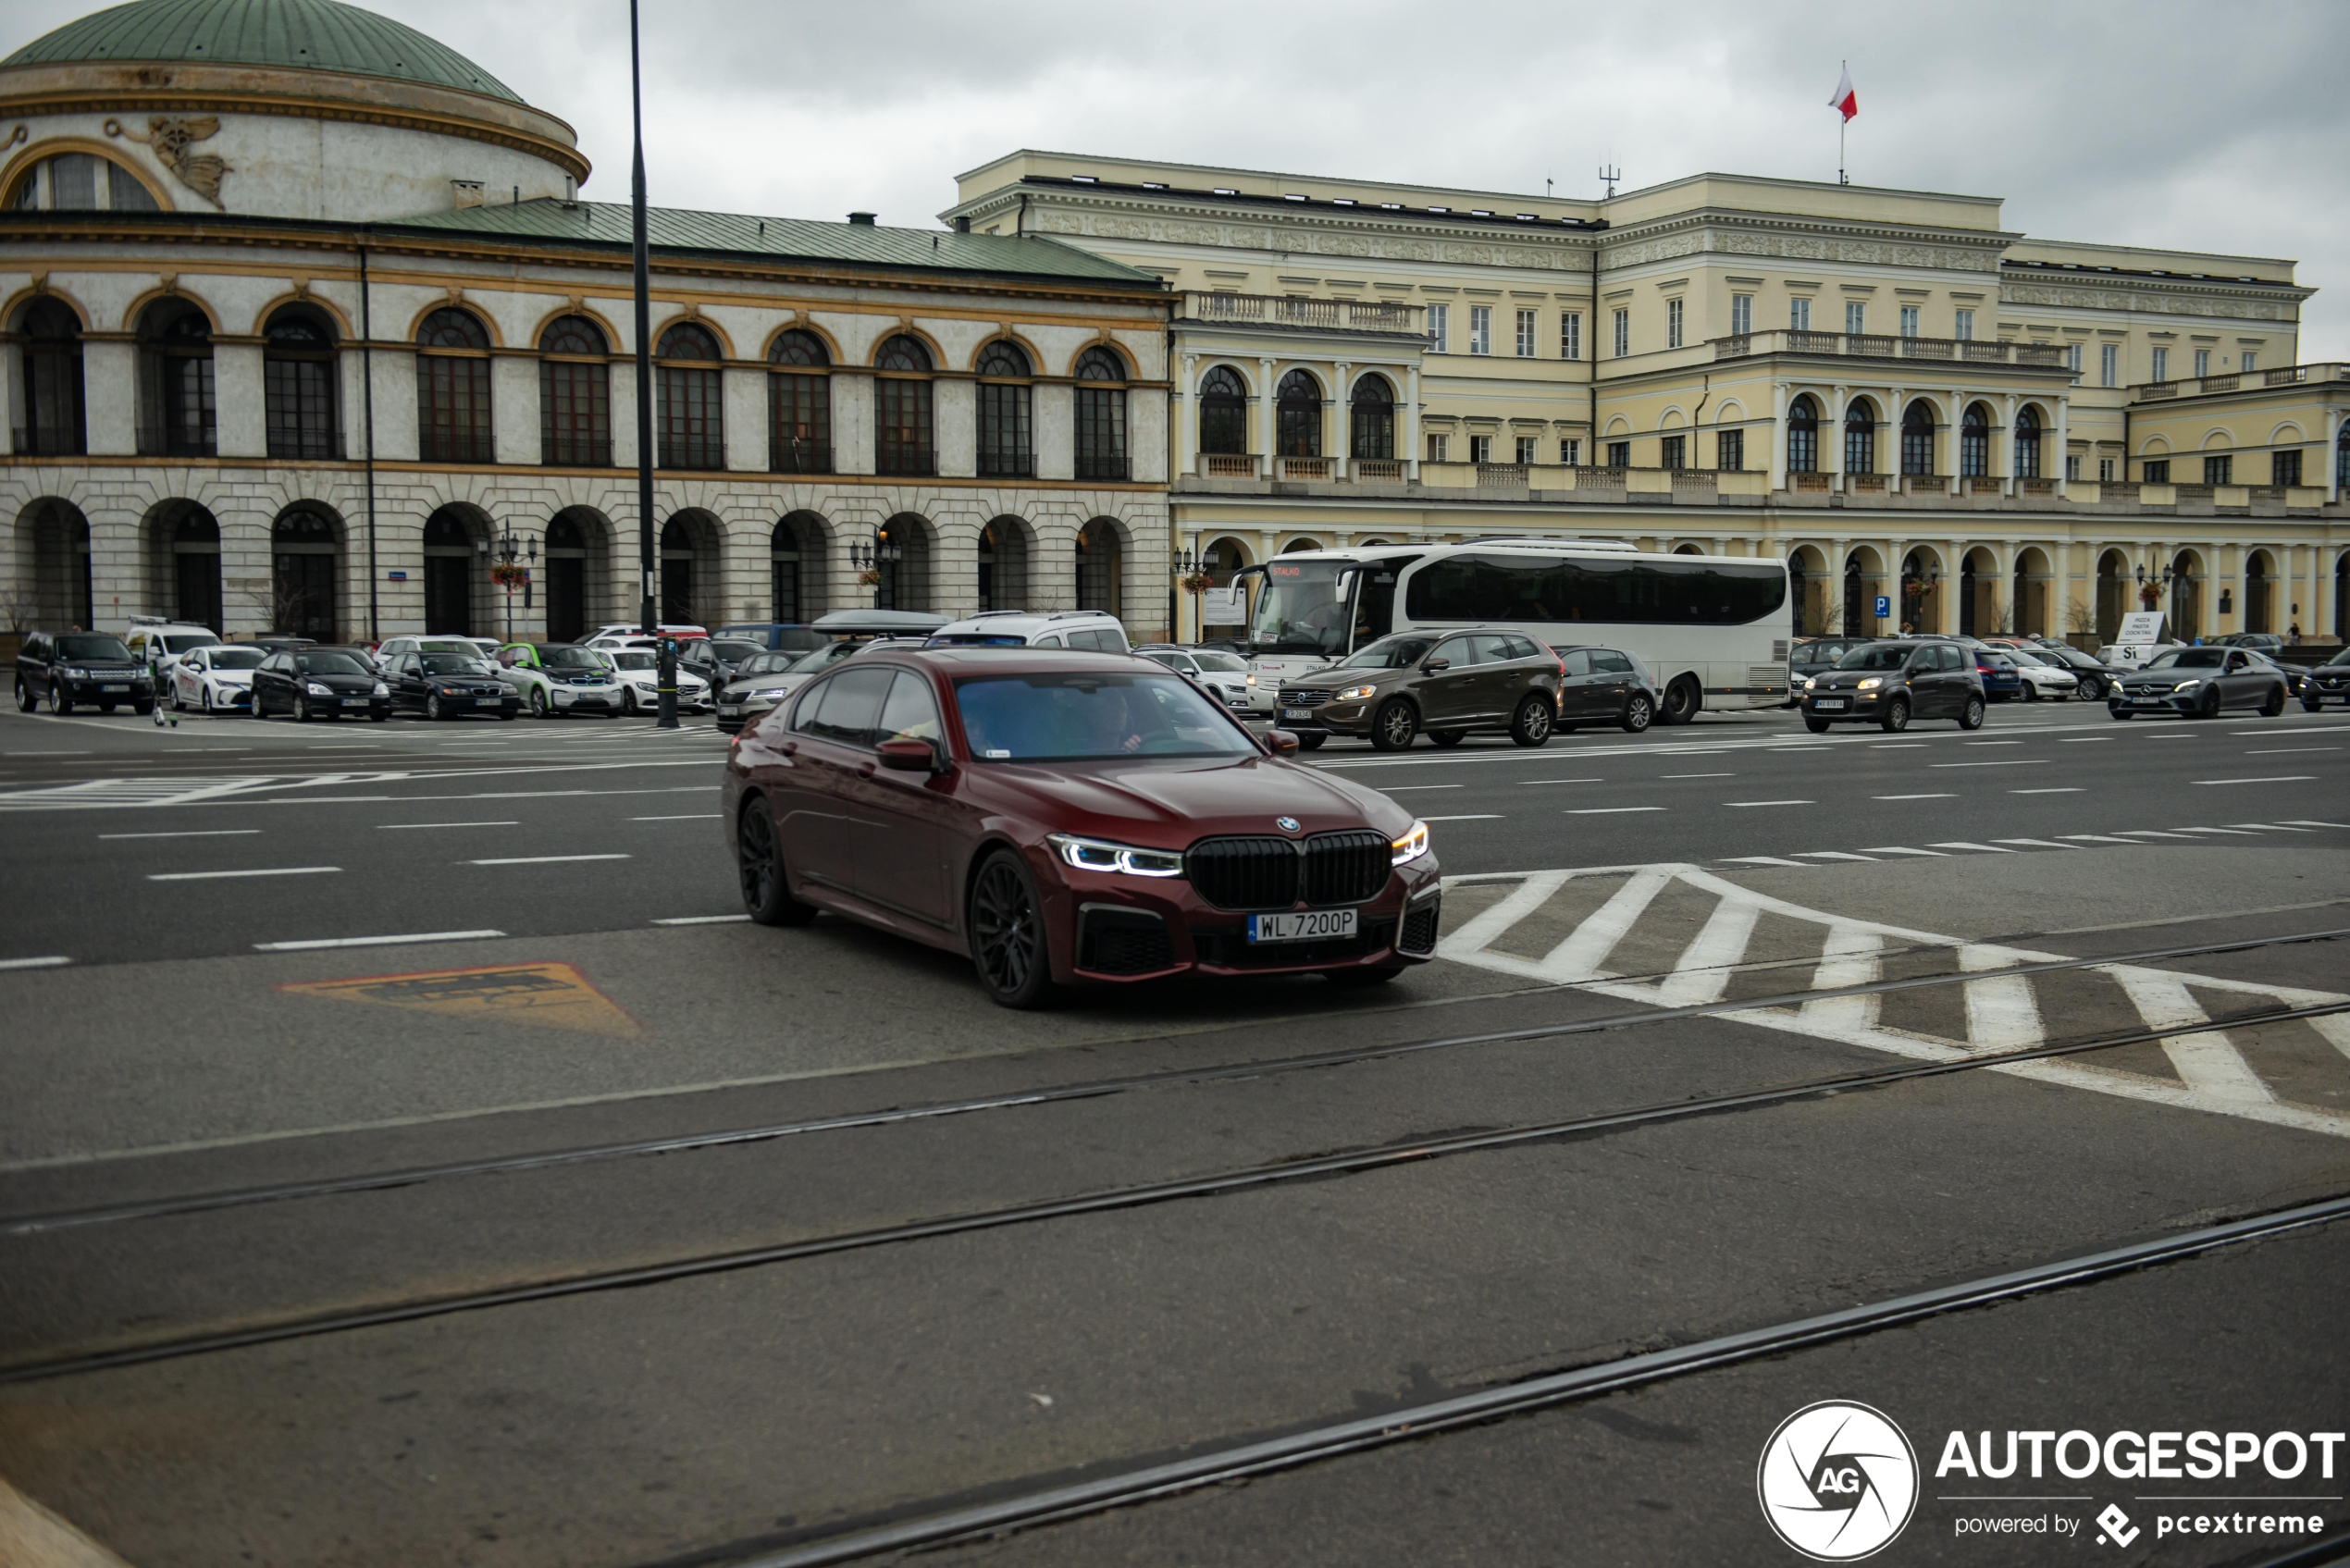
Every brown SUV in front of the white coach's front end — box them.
[1274,630,1565,752]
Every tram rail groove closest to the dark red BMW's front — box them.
[0,926,2350,1239]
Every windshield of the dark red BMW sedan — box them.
[954,673,1255,761]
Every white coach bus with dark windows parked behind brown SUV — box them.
[1239,538,1796,724]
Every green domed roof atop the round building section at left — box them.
[0,0,522,104]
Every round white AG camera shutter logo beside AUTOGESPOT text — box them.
[1755,1399,1918,1563]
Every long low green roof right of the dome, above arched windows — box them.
[383,191,1158,284]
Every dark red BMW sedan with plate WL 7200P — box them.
[726,648,1438,1006]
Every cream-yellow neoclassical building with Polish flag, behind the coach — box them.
[943,151,2350,637]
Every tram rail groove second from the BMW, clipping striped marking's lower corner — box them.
[0,1002,2350,1387]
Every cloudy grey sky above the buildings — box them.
[0,0,2350,362]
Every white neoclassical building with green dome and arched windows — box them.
[0,0,1172,639]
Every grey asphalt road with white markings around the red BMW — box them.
[0,705,2350,1568]
